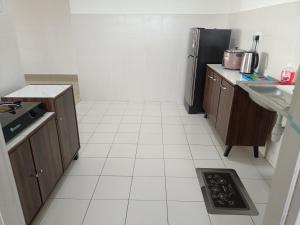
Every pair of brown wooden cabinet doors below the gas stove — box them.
[9,116,63,224]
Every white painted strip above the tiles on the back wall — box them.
[70,0,232,14]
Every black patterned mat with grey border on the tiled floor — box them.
[196,168,258,216]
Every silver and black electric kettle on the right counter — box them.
[240,51,259,74]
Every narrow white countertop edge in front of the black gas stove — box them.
[6,112,55,151]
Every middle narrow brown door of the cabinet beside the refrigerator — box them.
[208,73,221,126]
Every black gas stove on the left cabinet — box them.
[0,101,46,143]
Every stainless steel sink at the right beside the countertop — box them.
[239,82,292,117]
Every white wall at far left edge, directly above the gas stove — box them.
[0,2,24,96]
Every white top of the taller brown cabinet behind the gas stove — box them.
[4,85,71,98]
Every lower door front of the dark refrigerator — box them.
[185,55,197,106]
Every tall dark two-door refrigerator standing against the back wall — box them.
[184,28,231,113]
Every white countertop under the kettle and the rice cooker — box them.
[207,64,245,85]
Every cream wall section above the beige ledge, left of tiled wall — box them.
[10,0,77,74]
